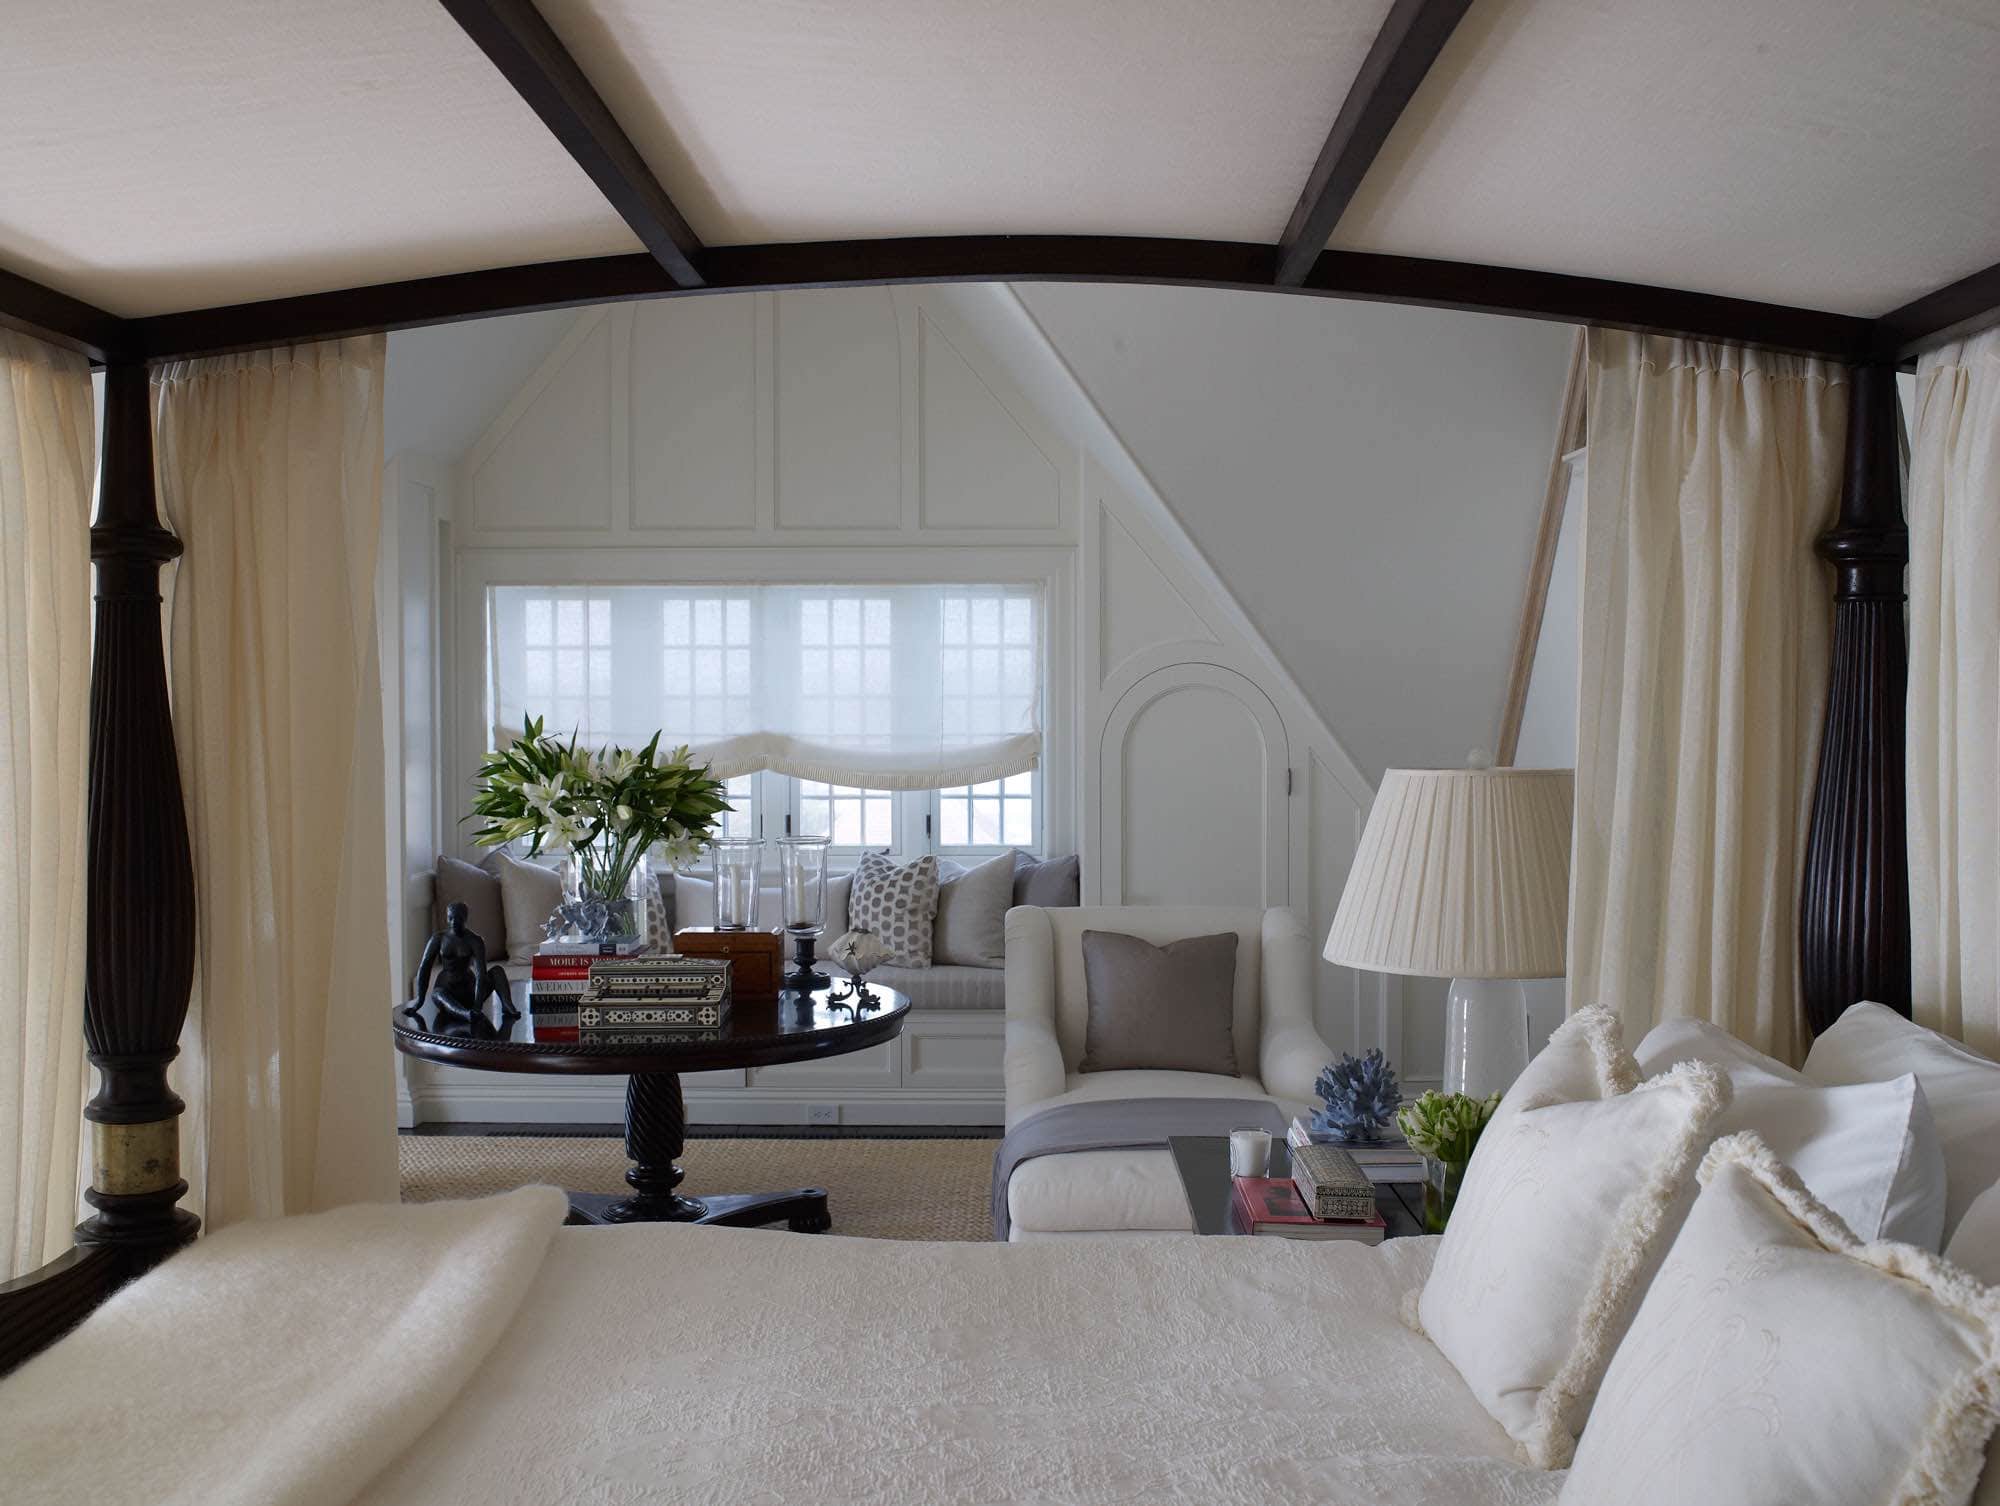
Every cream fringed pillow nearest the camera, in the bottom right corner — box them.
[1560,1134,2000,1506]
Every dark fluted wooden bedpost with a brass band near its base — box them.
[76,362,200,1274]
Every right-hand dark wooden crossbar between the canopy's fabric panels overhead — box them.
[1278,0,1472,288]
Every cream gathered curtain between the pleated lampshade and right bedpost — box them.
[1568,330,1846,1062]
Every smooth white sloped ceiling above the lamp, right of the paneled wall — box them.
[1018,284,1570,780]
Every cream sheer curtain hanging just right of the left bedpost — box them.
[154,336,396,1226]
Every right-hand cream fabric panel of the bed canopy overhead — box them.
[1332,0,2000,316]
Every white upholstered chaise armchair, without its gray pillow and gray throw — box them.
[1004,906,1332,1240]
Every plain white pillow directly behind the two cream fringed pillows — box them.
[1636,1020,1944,1250]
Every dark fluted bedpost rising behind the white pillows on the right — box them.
[1800,366,1910,1034]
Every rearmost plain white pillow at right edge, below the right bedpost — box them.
[1808,1000,2000,1240]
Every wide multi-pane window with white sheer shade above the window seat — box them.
[488,584,1044,854]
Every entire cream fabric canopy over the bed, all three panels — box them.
[0,0,2000,316]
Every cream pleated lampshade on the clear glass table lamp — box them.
[1326,768,1576,978]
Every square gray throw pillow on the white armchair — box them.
[1076,930,1236,1078]
